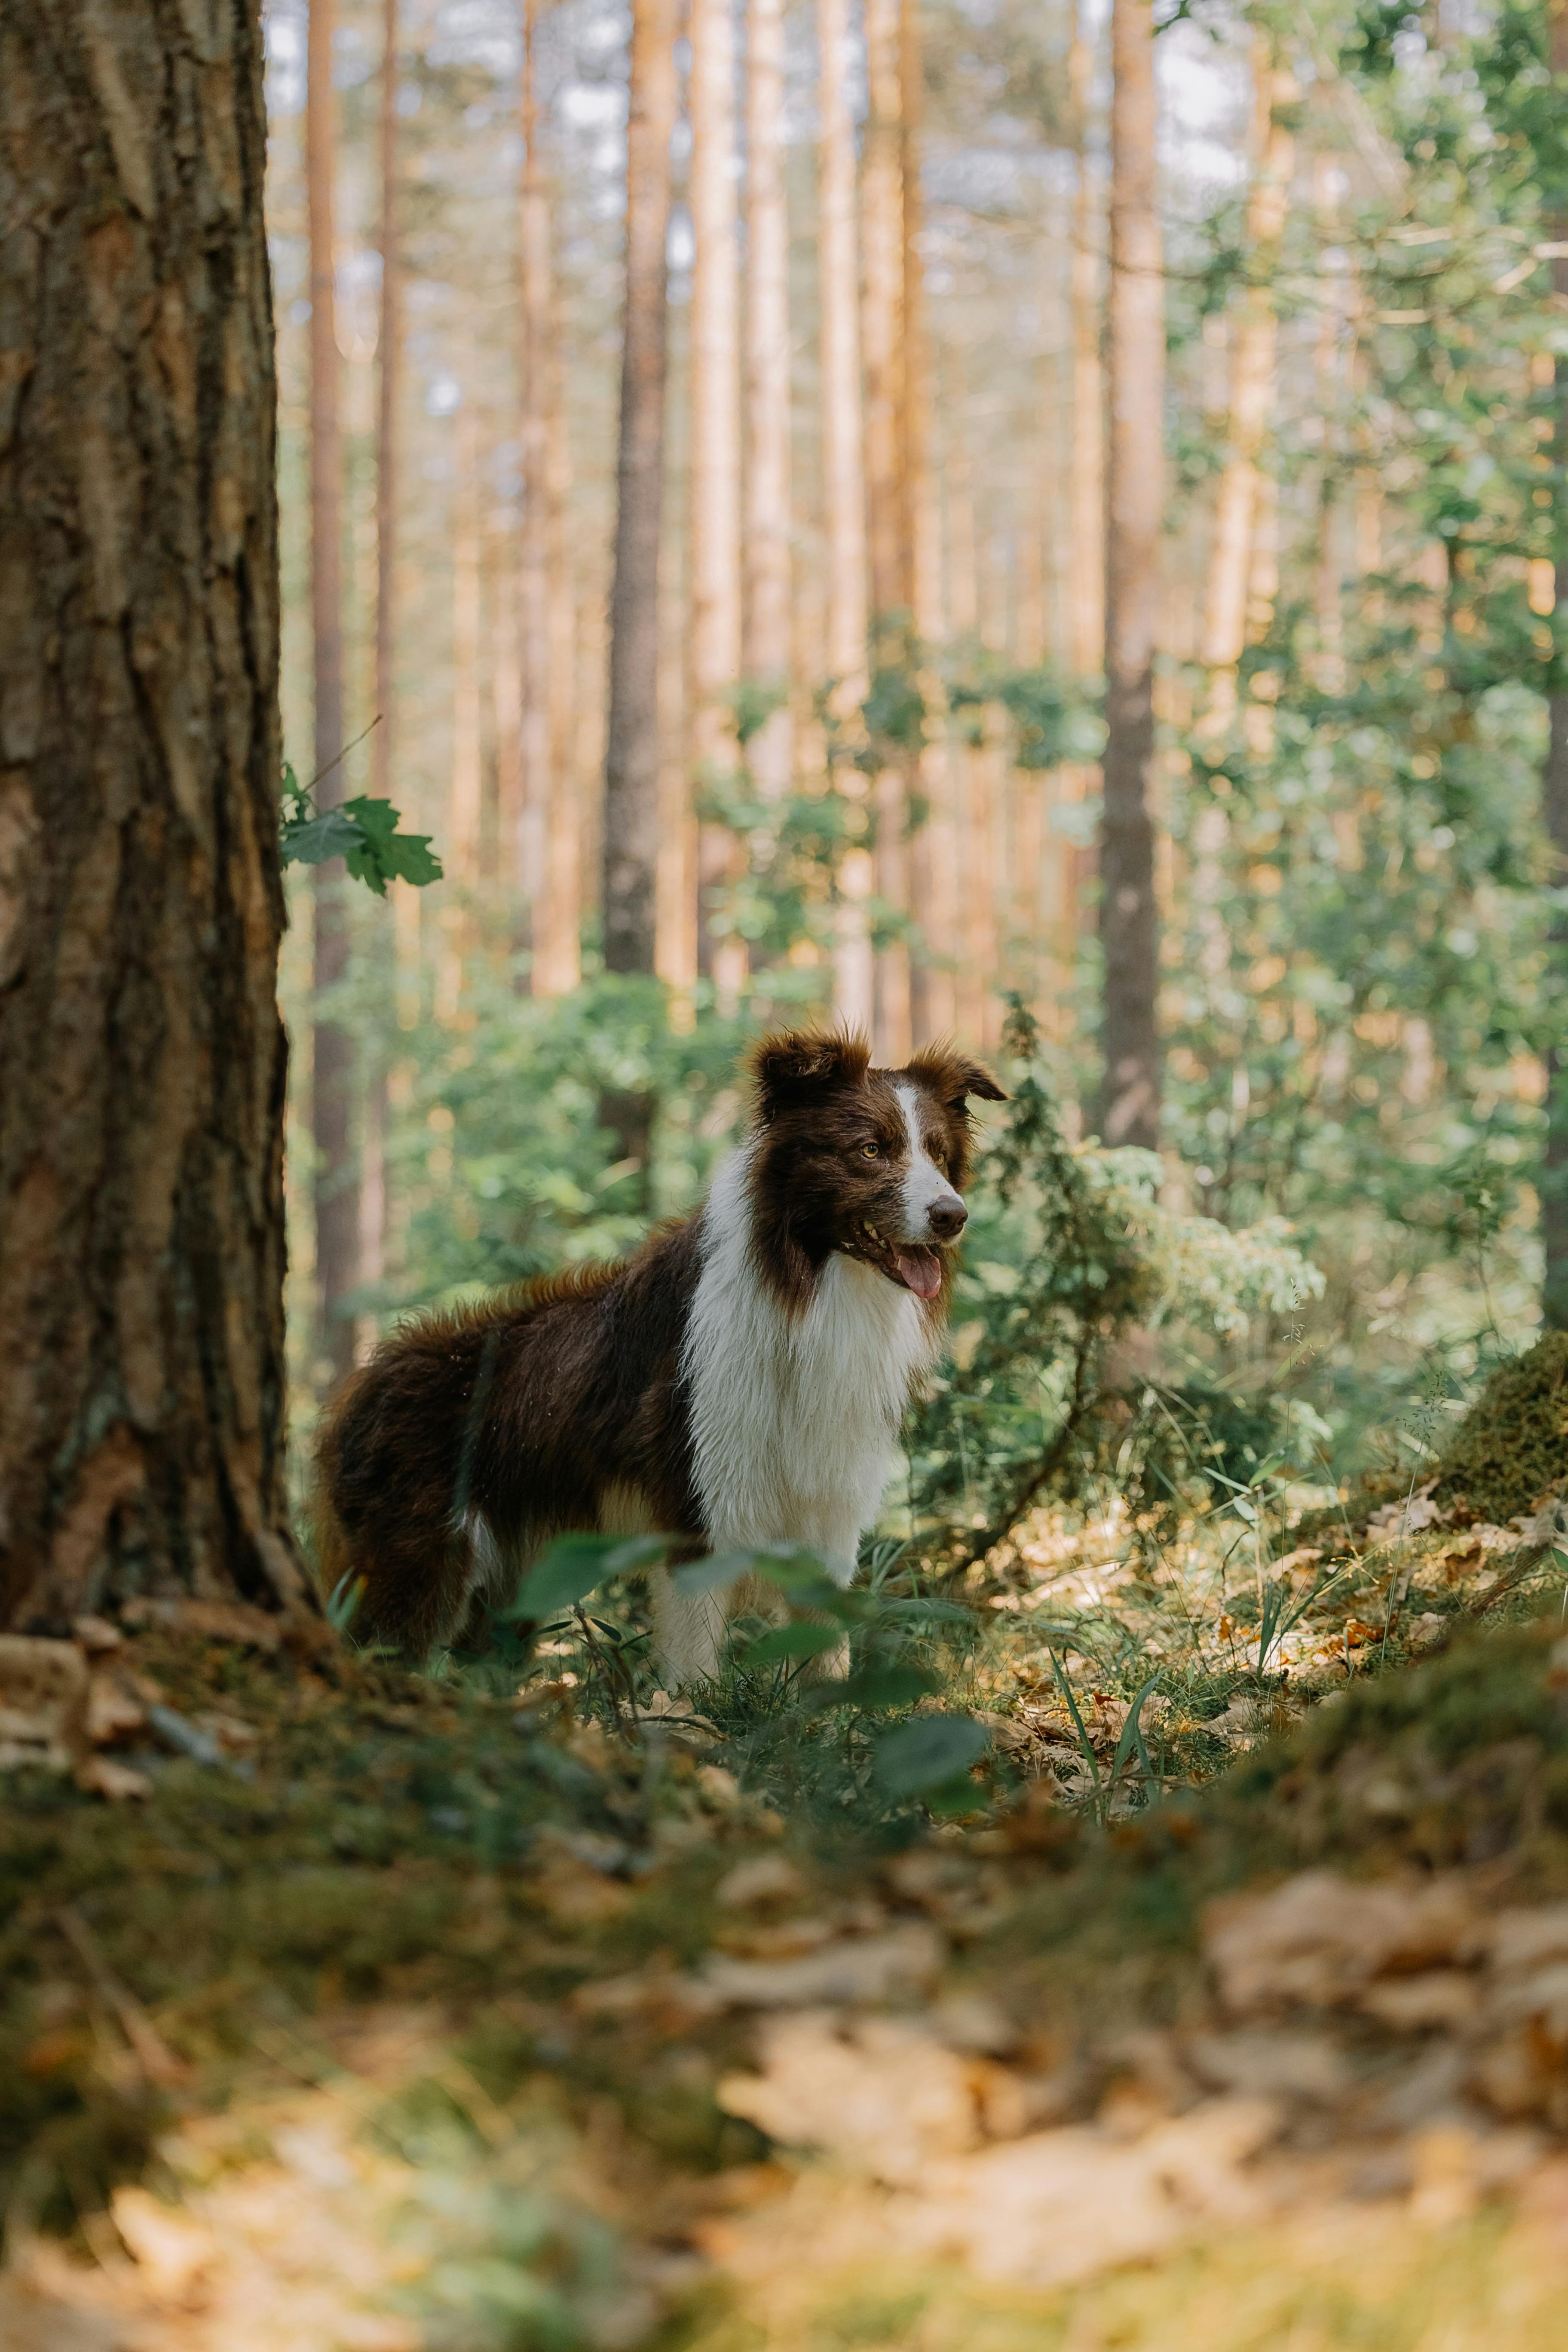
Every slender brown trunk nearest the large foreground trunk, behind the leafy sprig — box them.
[306,0,360,1381]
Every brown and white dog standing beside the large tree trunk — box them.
[317,1032,1004,1681]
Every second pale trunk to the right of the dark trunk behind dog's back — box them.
[743,0,795,799]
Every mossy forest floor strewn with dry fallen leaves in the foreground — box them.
[0,1458,1568,2352]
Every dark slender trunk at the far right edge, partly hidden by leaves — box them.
[1540,0,1568,1331]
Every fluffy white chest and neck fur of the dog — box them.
[682,1150,940,1583]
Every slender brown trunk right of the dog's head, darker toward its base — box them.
[1100,0,1166,1148]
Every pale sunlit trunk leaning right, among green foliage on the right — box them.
[1199,33,1295,732]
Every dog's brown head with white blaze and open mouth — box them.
[752,1030,1006,1301]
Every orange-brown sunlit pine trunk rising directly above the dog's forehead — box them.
[861,0,915,1063]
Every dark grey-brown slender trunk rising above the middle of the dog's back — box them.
[604,0,675,971]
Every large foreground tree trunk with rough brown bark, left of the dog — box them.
[0,0,303,1632]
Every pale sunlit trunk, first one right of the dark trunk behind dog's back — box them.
[686,0,745,1002]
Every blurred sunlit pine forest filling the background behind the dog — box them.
[266,0,1568,1496]
